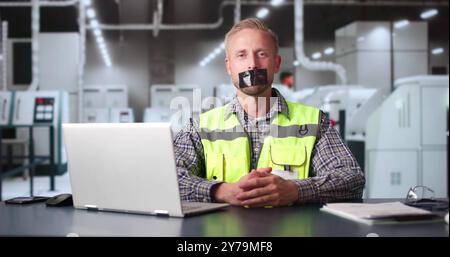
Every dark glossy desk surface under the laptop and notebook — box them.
[0,199,449,237]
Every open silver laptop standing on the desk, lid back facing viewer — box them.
[62,123,229,217]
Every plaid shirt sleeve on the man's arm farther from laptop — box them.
[295,112,365,203]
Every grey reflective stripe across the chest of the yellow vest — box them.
[199,124,318,141]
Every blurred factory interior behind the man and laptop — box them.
[0,0,449,199]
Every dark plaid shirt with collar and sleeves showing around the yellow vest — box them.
[174,89,365,203]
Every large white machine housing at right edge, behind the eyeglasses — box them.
[365,75,449,198]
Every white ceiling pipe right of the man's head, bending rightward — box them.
[294,0,347,85]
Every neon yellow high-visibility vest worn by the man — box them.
[199,102,320,183]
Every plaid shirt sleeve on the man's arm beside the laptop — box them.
[173,119,220,202]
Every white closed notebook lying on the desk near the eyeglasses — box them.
[321,202,442,225]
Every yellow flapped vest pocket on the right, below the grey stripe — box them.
[269,144,307,179]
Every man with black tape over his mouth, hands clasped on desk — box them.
[174,19,365,207]
